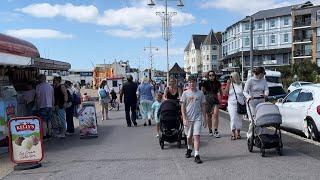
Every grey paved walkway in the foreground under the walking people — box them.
[4,102,320,180]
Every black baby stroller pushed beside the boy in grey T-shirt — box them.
[158,100,187,149]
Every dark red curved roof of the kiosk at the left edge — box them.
[0,33,40,58]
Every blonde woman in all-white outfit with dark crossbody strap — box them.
[224,72,245,140]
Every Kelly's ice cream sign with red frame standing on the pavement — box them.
[9,117,43,164]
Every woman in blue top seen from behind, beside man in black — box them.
[137,78,153,126]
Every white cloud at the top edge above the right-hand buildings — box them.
[200,0,301,15]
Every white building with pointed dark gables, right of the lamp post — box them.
[184,30,221,74]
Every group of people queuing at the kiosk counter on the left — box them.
[23,74,81,140]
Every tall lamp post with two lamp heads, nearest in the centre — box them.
[148,0,184,86]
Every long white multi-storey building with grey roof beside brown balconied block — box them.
[222,6,292,70]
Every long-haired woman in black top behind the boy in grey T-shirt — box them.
[201,71,221,138]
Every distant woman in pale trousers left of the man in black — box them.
[98,80,110,121]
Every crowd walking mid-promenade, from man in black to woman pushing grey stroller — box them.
[114,67,269,163]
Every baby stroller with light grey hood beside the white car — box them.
[248,97,283,157]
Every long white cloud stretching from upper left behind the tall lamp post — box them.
[16,0,196,29]
